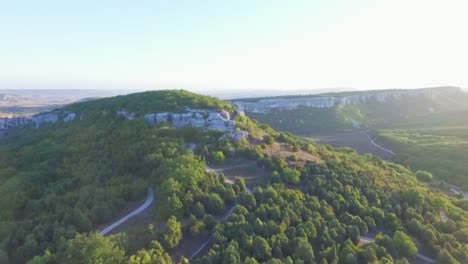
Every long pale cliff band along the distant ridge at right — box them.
[234,87,461,113]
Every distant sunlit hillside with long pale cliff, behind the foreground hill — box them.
[234,87,468,191]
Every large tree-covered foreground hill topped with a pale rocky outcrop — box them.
[0,91,468,264]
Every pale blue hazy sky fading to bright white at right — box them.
[0,0,468,89]
